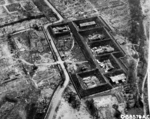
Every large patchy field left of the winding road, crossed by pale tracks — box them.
[0,30,62,119]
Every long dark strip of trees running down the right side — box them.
[124,0,147,113]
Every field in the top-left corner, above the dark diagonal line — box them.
[0,0,58,27]
